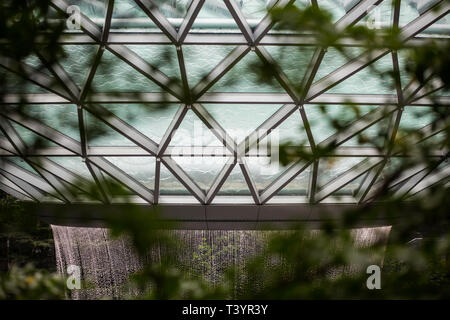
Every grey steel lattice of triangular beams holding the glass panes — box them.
[0,0,450,214]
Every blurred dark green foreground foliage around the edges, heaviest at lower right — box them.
[0,1,450,299]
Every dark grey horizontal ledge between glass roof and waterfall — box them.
[26,203,412,230]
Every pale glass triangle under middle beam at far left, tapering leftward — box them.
[16,104,80,141]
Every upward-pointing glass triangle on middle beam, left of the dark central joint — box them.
[91,50,162,92]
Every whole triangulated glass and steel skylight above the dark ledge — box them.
[0,0,450,209]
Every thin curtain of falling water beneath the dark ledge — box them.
[52,225,391,299]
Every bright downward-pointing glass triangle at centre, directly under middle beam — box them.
[203,104,281,143]
